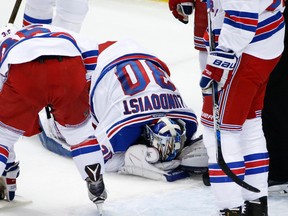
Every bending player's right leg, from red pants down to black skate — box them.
[50,57,107,204]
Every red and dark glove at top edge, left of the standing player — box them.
[169,0,194,24]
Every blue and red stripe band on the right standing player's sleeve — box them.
[224,10,258,32]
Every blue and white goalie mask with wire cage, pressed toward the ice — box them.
[145,117,186,161]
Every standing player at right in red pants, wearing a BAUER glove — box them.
[200,0,284,216]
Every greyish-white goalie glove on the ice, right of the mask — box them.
[177,135,208,174]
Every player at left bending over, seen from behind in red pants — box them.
[0,24,106,211]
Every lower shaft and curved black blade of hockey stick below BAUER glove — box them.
[212,81,260,193]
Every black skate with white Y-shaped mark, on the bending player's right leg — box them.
[85,163,107,216]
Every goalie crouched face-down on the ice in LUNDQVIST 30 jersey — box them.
[39,40,208,182]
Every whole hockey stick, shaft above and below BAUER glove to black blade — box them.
[206,0,260,193]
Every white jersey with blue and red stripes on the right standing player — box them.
[205,0,284,59]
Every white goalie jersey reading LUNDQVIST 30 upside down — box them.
[90,40,197,153]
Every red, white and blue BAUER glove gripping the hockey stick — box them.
[200,50,237,94]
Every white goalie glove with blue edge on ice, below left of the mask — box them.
[119,144,188,182]
